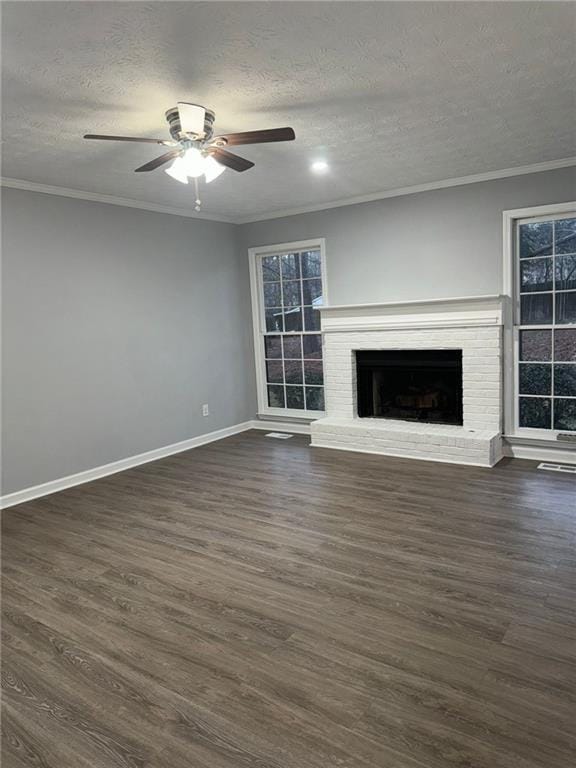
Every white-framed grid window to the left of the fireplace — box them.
[250,240,326,418]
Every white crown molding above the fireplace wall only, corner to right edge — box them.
[236,157,576,224]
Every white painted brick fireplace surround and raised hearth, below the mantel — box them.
[312,316,502,466]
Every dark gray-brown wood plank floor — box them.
[2,432,576,768]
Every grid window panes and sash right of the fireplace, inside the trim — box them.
[514,210,576,437]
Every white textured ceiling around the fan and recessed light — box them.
[2,2,576,220]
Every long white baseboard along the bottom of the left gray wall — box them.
[0,421,254,509]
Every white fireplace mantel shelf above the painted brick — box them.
[319,295,506,333]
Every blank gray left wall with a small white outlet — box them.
[2,189,255,493]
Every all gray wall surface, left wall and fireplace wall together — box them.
[2,168,576,493]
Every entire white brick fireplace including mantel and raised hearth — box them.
[311,296,502,466]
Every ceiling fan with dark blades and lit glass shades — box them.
[84,101,296,210]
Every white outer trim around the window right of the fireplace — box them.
[502,201,576,445]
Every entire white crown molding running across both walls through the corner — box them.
[0,157,576,224]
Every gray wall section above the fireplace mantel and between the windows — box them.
[240,168,576,304]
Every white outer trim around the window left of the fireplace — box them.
[248,237,328,421]
